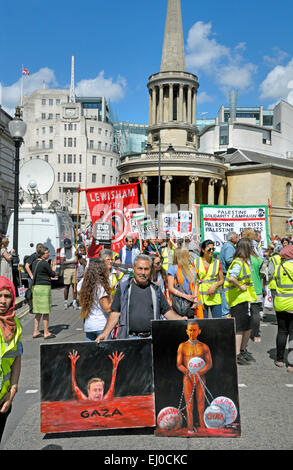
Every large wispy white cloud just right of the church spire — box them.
[186,21,257,93]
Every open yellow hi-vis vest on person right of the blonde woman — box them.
[194,257,221,305]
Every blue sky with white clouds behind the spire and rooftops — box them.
[0,0,293,123]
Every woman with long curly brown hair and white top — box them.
[79,258,112,341]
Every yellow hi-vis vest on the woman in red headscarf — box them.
[0,318,22,399]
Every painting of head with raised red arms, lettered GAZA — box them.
[41,339,155,433]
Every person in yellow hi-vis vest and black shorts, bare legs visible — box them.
[224,238,257,365]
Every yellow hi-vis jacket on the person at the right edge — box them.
[274,259,293,312]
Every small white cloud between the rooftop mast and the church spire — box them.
[75,70,126,101]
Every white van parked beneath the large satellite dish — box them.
[6,208,75,280]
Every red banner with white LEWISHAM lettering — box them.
[85,183,139,253]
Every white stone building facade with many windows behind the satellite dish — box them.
[21,89,119,224]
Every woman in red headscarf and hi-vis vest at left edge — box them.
[0,276,23,442]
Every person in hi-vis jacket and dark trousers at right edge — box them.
[274,245,293,372]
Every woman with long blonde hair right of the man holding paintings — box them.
[168,248,198,318]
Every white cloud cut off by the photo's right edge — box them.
[260,58,293,104]
